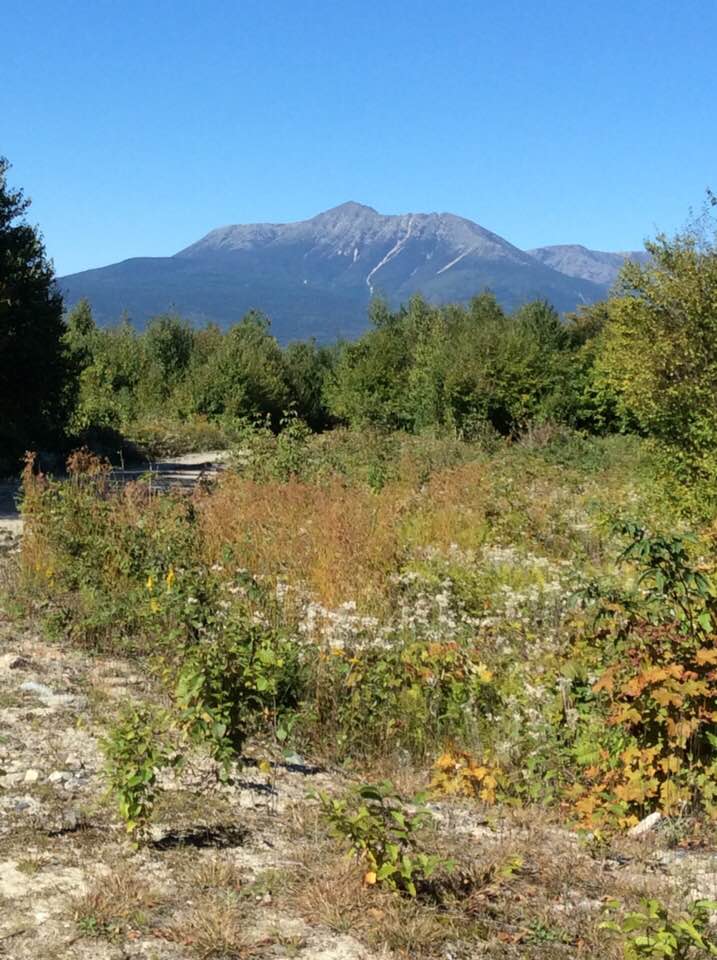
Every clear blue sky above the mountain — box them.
[0,0,717,274]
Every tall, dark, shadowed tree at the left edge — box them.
[0,158,72,465]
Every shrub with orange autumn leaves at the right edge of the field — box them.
[577,523,717,823]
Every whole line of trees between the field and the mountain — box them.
[0,160,717,496]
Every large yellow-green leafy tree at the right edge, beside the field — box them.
[599,217,717,481]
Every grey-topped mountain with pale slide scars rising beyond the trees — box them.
[59,202,636,342]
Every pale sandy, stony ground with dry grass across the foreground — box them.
[0,516,717,960]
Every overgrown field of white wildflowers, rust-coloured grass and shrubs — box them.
[9,424,717,957]
